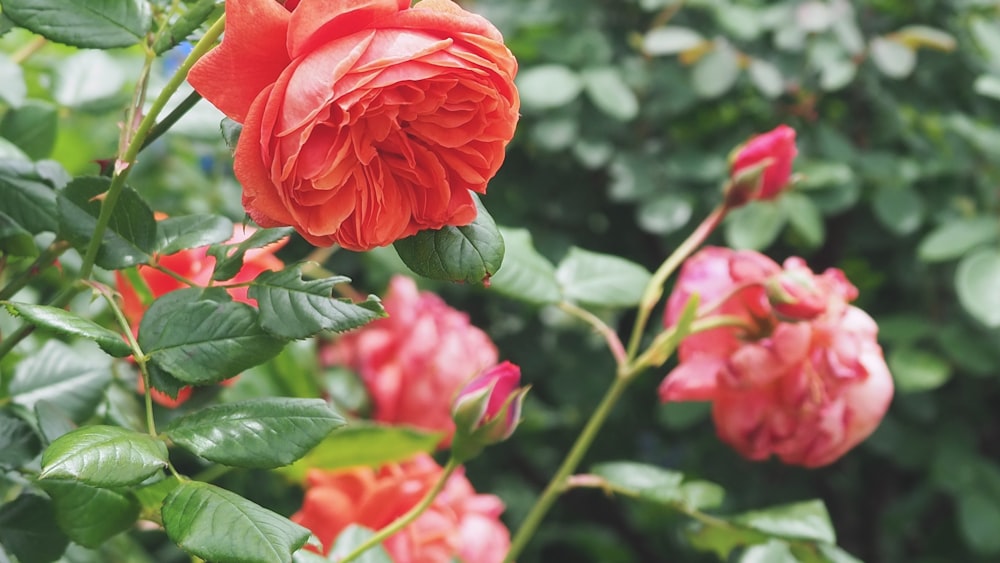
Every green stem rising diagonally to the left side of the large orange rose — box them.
[80,15,226,279]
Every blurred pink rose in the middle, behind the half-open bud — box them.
[323,276,497,444]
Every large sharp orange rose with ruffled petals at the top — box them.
[189,0,519,250]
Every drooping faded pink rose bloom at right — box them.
[660,248,893,467]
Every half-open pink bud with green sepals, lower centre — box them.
[451,362,528,460]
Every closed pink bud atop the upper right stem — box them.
[726,125,798,207]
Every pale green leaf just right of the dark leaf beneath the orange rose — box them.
[490,227,562,305]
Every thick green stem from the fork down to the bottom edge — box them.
[504,374,634,563]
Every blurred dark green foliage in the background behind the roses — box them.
[0,0,1000,563]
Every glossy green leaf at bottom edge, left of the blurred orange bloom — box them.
[163,481,309,563]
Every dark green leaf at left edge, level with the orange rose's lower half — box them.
[0,160,58,234]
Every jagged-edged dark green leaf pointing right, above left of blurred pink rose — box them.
[248,264,386,340]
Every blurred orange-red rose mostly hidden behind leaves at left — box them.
[115,225,288,408]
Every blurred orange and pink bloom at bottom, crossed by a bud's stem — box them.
[292,454,510,563]
